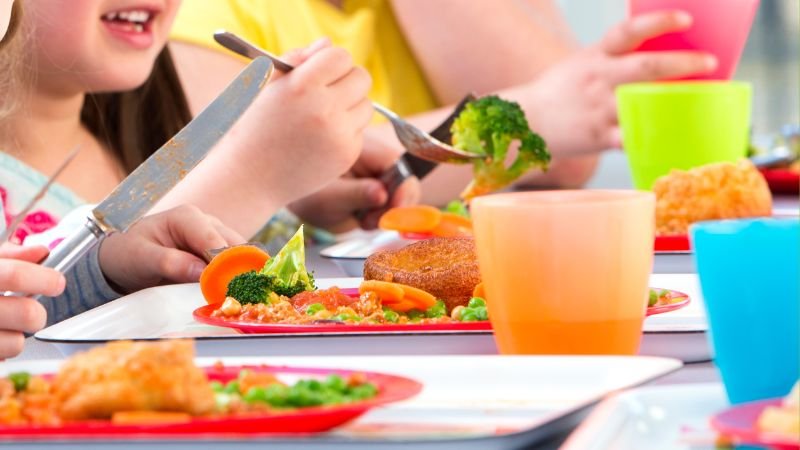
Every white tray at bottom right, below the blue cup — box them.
[562,383,728,450]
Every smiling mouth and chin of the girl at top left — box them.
[26,0,181,93]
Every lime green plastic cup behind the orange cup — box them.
[616,81,752,190]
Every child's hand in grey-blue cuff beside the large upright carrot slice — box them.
[99,206,244,293]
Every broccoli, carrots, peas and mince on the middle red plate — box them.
[203,227,482,325]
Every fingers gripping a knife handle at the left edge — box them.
[0,244,66,359]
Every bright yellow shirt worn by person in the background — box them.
[171,0,437,115]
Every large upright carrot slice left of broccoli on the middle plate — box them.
[200,245,269,303]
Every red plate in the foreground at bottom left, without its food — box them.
[0,366,422,442]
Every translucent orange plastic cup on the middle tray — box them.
[470,190,655,355]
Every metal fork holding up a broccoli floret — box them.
[214,30,481,164]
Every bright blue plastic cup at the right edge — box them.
[690,219,800,404]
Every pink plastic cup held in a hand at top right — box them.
[628,0,759,80]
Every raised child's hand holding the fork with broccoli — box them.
[230,41,373,204]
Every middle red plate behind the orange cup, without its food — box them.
[192,288,689,334]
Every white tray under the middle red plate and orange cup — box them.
[35,274,709,362]
